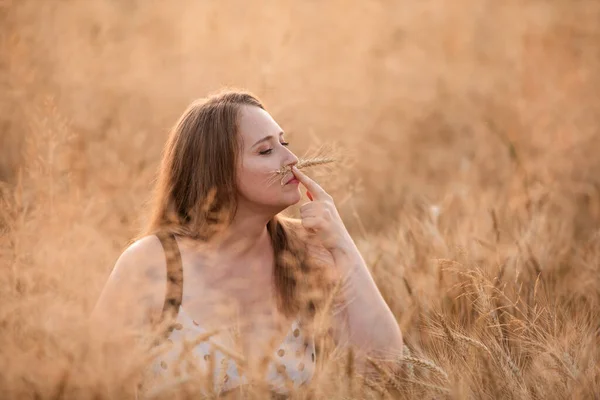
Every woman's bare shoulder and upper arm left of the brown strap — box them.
[94,235,167,325]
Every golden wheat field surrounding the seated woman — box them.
[0,0,600,399]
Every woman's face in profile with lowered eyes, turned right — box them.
[236,106,301,213]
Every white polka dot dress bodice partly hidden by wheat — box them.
[145,308,315,393]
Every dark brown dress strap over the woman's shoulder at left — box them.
[156,232,183,335]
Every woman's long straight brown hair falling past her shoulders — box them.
[144,90,315,315]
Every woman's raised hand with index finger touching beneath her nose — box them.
[292,166,352,252]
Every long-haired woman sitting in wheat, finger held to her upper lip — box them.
[95,91,402,392]
